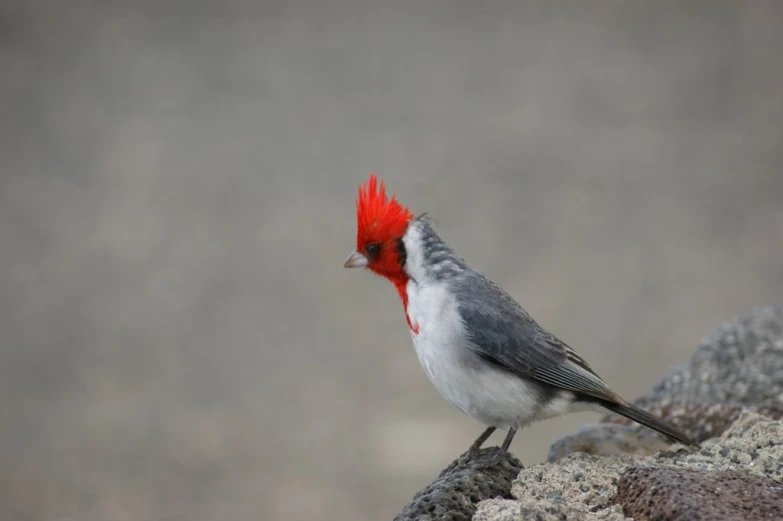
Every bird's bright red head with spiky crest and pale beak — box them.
[345,174,413,284]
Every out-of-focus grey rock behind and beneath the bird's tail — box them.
[547,306,783,461]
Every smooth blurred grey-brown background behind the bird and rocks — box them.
[0,0,783,521]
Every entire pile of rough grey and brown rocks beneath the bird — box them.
[395,307,783,521]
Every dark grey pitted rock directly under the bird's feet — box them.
[394,447,522,521]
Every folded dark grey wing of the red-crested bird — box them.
[458,273,623,403]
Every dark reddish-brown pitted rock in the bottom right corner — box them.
[614,467,783,521]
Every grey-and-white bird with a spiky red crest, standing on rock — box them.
[344,173,699,465]
